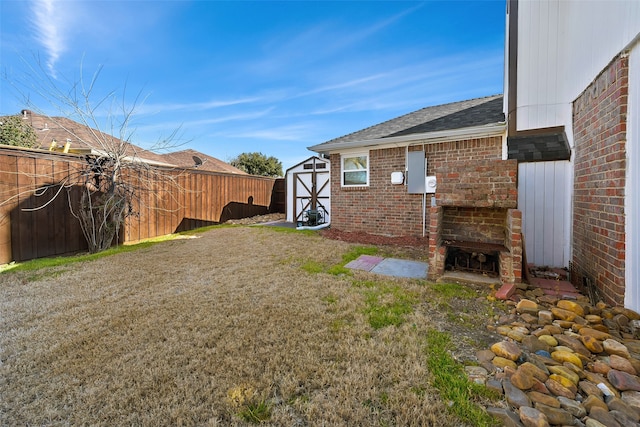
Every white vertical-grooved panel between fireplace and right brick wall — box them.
[518,161,572,267]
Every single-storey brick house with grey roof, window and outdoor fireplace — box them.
[309,95,522,283]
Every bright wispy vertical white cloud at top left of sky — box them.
[30,0,66,76]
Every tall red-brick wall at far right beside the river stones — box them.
[573,55,629,304]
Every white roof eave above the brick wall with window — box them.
[307,122,507,154]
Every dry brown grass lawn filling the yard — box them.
[0,227,500,426]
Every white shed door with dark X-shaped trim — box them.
[293,170,331,226]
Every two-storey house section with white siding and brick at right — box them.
[505,0,640,310]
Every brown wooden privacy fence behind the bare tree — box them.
[0,147,285,264]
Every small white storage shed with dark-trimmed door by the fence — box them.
[286,156,331,226]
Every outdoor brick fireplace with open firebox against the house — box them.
[429,160,522,284]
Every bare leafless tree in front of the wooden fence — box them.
[4,61,185,253]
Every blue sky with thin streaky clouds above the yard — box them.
[0,0,505,169]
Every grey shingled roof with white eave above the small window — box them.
[309,95,505,152]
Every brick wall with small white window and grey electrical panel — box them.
[331,137,502,237]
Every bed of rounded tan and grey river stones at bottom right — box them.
[472,280,640,427]
